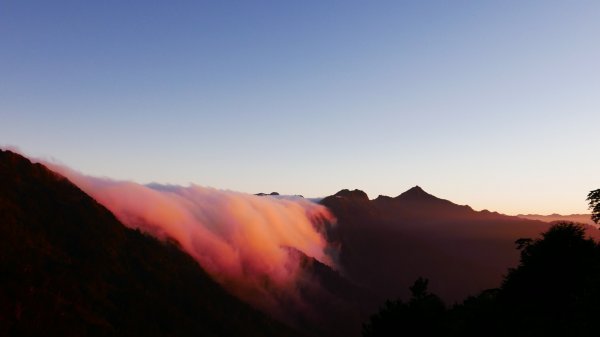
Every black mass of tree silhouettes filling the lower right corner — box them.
[363,222,600,337]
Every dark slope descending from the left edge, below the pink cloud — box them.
[0,151,296,337]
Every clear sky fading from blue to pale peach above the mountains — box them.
[0,0,600,214]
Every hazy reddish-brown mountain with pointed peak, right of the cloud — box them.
[321,186,598,303]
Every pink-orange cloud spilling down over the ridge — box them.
[43,162,334,311]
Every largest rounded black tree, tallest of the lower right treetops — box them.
[498,223,600,336]
